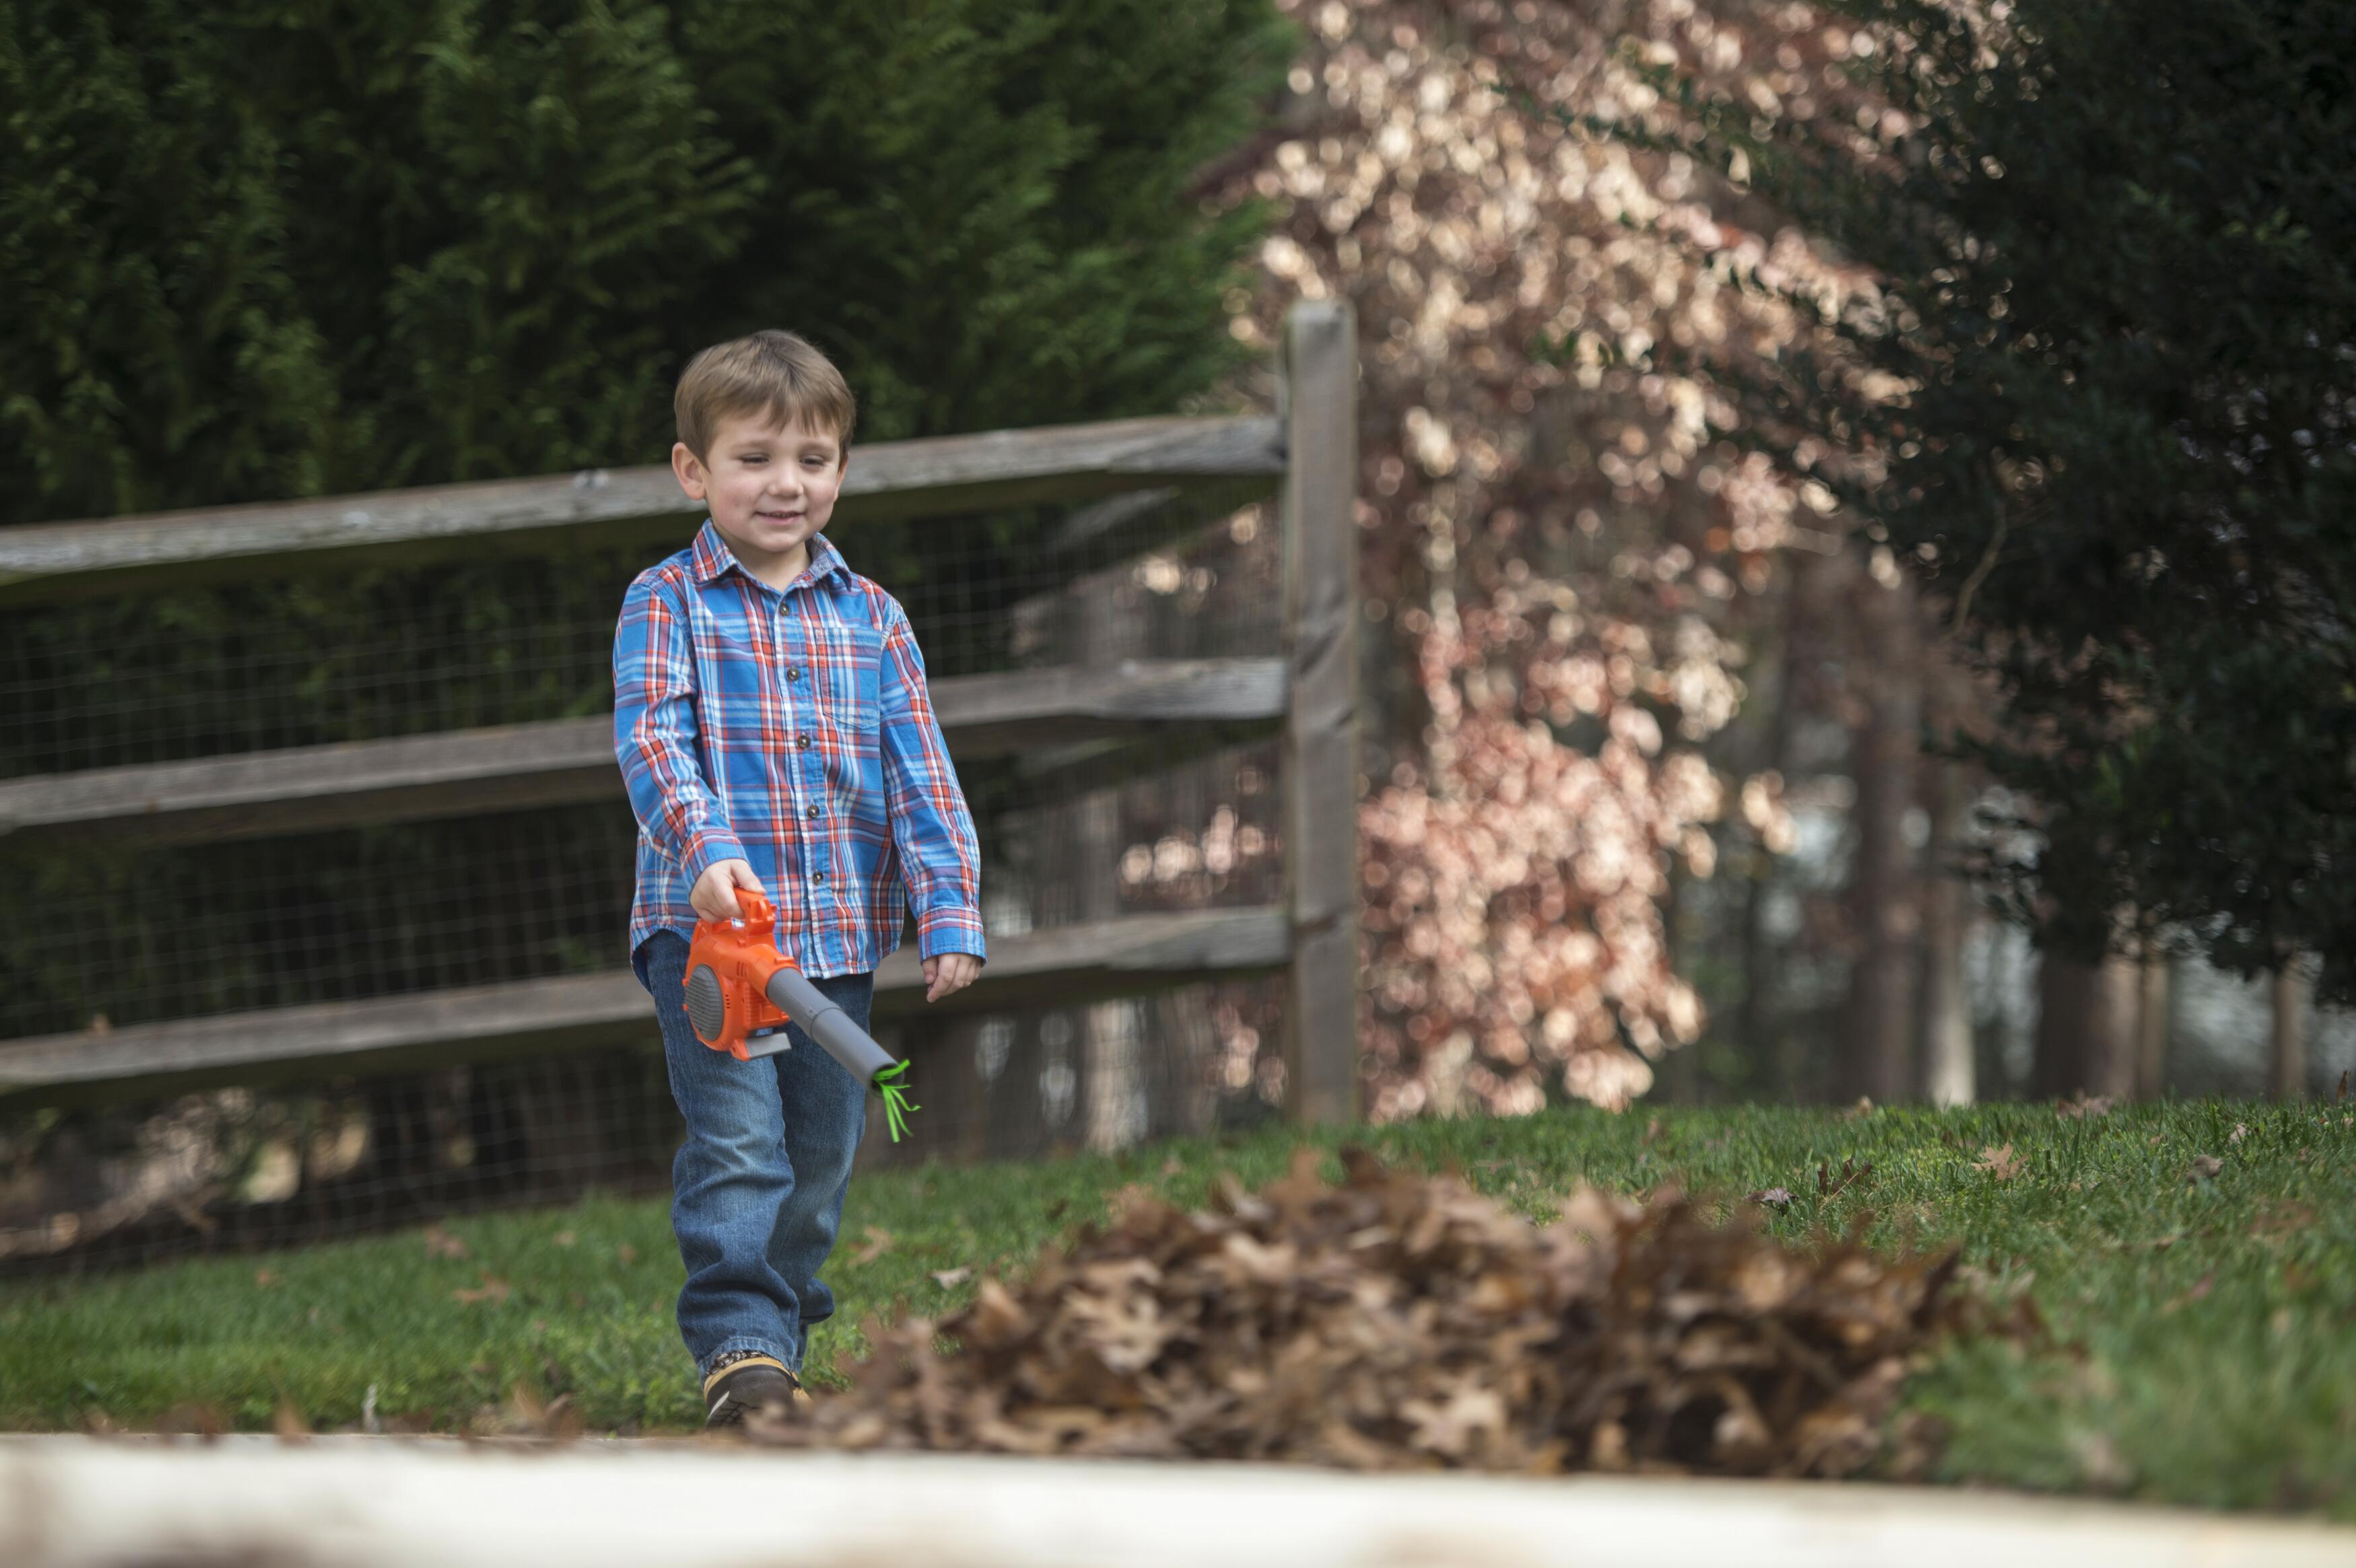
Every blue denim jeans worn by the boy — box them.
[632,930,874,1375]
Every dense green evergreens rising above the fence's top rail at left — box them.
[0,0,1289,520]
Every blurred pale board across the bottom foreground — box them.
[0,1436,2356,1568]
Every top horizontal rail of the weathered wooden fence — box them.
[0,419,1284,603]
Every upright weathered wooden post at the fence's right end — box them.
[1284,302,1359,1123]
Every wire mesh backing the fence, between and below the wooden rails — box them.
[0,466,1284,1271]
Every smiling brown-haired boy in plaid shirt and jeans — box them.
[613,332,985,1427]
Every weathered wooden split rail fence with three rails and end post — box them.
[0,306,1357,1121]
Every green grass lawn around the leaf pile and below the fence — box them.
[0,1102,2356,1519]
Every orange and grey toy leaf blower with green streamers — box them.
[688,887,921,1142]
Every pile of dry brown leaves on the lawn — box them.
[754,1151,1982,1476]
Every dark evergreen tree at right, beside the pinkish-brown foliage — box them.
[1614,0,2356,996]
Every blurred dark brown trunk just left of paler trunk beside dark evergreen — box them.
[1847,562,1922,1104]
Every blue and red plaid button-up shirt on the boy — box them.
[613,520,985,975]
